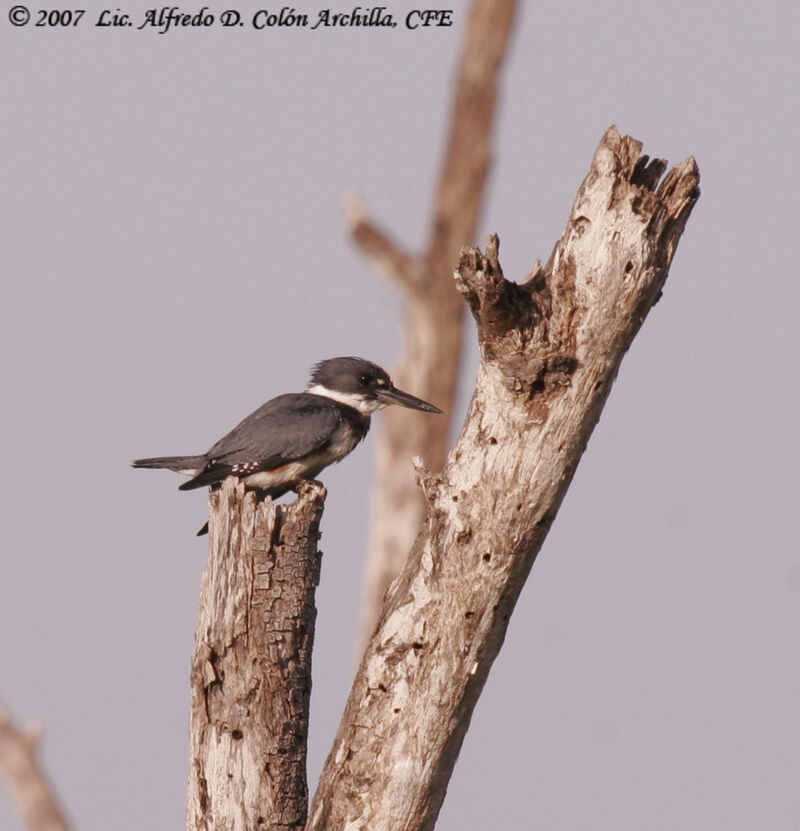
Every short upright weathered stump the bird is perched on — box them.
[186,479,325,831]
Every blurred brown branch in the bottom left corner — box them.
[0,704,69,831]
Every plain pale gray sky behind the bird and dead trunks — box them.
[0,0,800,831]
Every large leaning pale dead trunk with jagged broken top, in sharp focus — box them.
[307,128,699,831]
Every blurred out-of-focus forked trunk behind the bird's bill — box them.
[348,0,516,642]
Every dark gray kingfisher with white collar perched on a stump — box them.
[131,357,442,536]
